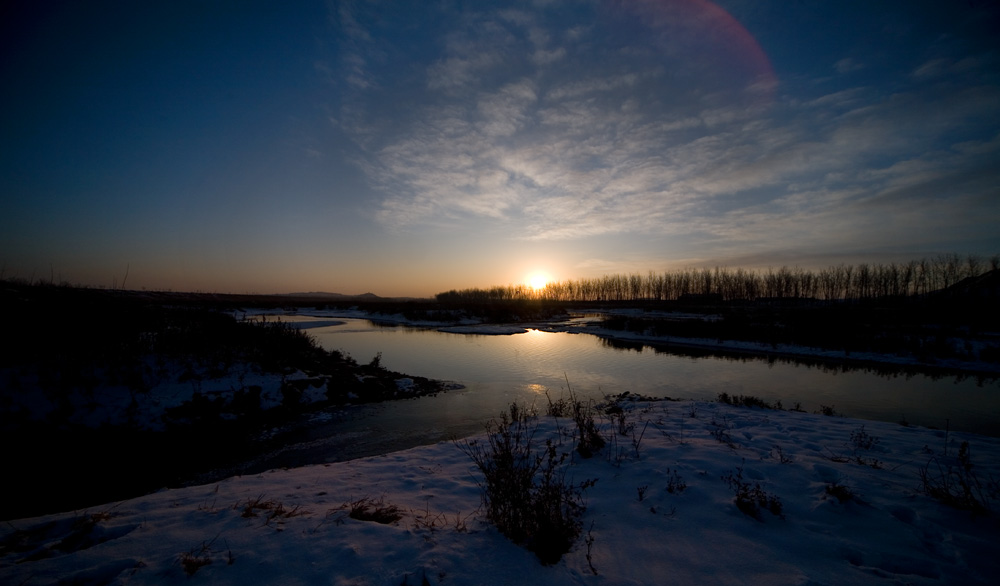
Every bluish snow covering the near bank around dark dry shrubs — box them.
[0,400,1000,586]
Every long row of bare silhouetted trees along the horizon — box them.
[436,253,1000,303]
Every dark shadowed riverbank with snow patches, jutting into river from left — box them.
[0,287,454,519]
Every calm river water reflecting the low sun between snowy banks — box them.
[229,316,1000,471]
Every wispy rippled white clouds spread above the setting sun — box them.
[330,0,1000,260]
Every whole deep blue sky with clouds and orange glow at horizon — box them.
[0,0,1000,296]
